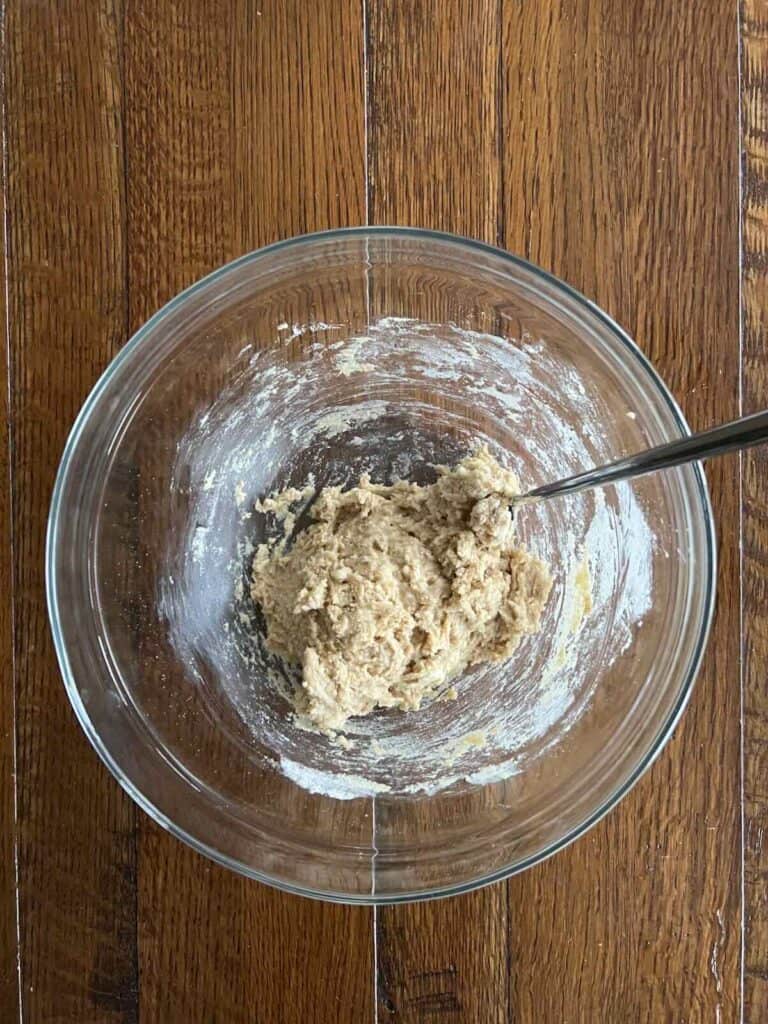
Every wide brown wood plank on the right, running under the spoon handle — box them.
[502,0,740,1022]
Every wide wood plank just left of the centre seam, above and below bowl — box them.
[125,0,373,1024]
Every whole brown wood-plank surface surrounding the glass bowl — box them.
[0,0,768,1024]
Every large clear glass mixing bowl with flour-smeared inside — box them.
[47,228,715,902]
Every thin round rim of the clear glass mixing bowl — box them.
[45,225,717,905]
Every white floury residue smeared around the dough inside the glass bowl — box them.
[159,317,654,800]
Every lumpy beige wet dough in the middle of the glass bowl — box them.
[251,449,551,733]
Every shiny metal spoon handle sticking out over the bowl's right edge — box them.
[528,410,768,504]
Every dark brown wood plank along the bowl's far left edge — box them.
[4,0,137,1022]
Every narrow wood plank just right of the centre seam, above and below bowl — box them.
[368,0,507,1024]
